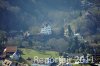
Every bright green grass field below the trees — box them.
[21,48,59,59]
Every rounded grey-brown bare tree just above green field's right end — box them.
[47,38,68,52]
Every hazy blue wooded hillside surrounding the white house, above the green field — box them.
[0,0,100,53]
